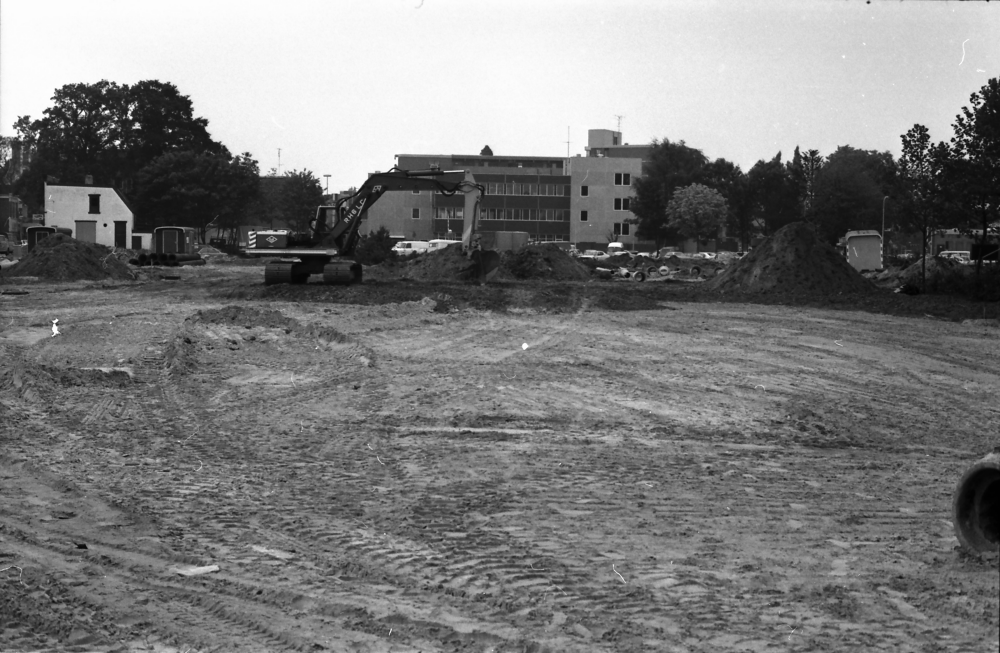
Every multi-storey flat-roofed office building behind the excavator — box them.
[362,129,649,249]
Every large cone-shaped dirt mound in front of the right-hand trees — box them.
[706,222,875,296]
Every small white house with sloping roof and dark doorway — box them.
[45,184,142,249]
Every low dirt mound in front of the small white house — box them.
[4,234,136,281]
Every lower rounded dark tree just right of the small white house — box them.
[135,151,259,239]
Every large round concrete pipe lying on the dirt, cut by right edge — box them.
[951,447,1000,553]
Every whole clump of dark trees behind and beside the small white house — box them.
[0,80,323,237]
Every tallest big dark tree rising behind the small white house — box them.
[14,80,229,211]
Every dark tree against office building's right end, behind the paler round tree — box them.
[630,139,708,247]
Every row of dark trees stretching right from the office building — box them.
[631,79,1000,268]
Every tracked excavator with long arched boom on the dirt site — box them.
[246,167,500,285]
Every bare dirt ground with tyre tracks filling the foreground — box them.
[0,265,1000,653]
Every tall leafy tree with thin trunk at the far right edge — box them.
[951,77,1000,277]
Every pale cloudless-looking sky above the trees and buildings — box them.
[0,0,1000,190]
